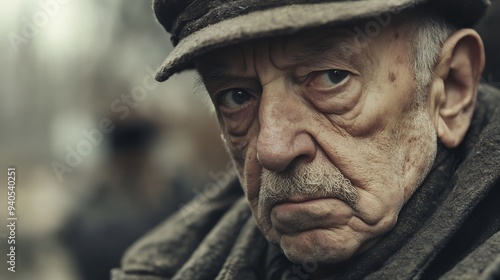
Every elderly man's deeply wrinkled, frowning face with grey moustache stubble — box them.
[197,23,436,264]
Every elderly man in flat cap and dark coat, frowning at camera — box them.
[112,0,500,279]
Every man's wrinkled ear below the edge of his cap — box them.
[430,29,485,148]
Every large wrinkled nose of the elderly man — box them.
[257,83,316,172]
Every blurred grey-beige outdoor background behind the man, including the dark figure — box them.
[0,0,500,280]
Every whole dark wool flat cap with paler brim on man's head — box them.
[153,0,489,82]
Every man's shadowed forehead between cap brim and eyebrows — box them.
[197,27,365,77]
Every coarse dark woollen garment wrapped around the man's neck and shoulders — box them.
[111,85,500,280]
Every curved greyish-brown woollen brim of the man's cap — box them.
[156,0,425,82]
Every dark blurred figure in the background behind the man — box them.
[62,112,192,280]
